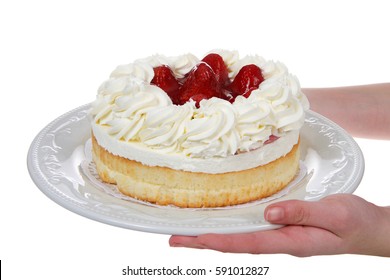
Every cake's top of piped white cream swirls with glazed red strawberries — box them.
[90,50,309,161]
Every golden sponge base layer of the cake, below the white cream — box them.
[92,137,300,208]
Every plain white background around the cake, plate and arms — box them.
[0,0,390,279]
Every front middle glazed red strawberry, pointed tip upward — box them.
[178,62,221,107]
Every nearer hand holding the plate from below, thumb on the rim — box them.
[169,194,390,257]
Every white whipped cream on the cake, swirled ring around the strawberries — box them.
[90,50,309,173]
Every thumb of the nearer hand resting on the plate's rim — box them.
[264,200,337,228]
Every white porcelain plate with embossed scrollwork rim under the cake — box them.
[27,104,364,235]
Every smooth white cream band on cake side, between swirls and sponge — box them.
[93,124,299,174]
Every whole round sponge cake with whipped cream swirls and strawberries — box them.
[90,50,309,208]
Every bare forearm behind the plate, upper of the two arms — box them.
[303,83,390,139]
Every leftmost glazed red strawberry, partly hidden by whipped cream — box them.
[150,65,180,103]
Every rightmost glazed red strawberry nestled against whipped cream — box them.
[229,64,264,97]
